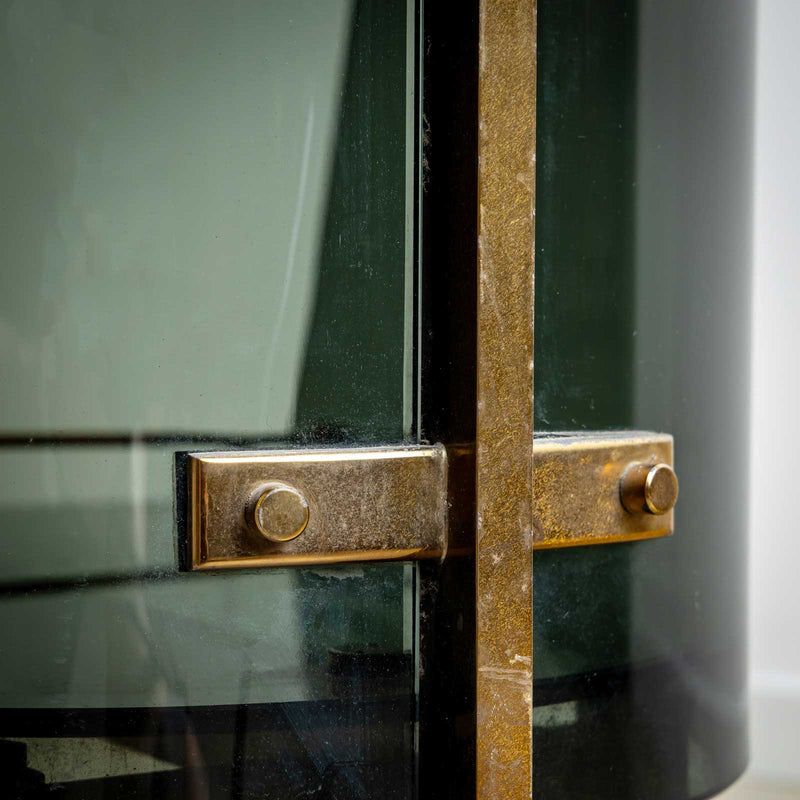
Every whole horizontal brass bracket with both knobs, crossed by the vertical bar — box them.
[181,432,677,570]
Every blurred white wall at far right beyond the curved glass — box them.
[750,0,800,784]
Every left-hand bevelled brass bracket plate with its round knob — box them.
[187,445,447,570]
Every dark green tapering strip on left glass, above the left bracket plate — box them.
[297,0,414,441]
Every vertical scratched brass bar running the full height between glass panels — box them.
[476,0,536,800]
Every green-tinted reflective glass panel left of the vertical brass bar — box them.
[0,0,417,798]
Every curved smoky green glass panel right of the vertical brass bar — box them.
[533,0,754,800]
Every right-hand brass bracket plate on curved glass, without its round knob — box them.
[533,431,677,548]
